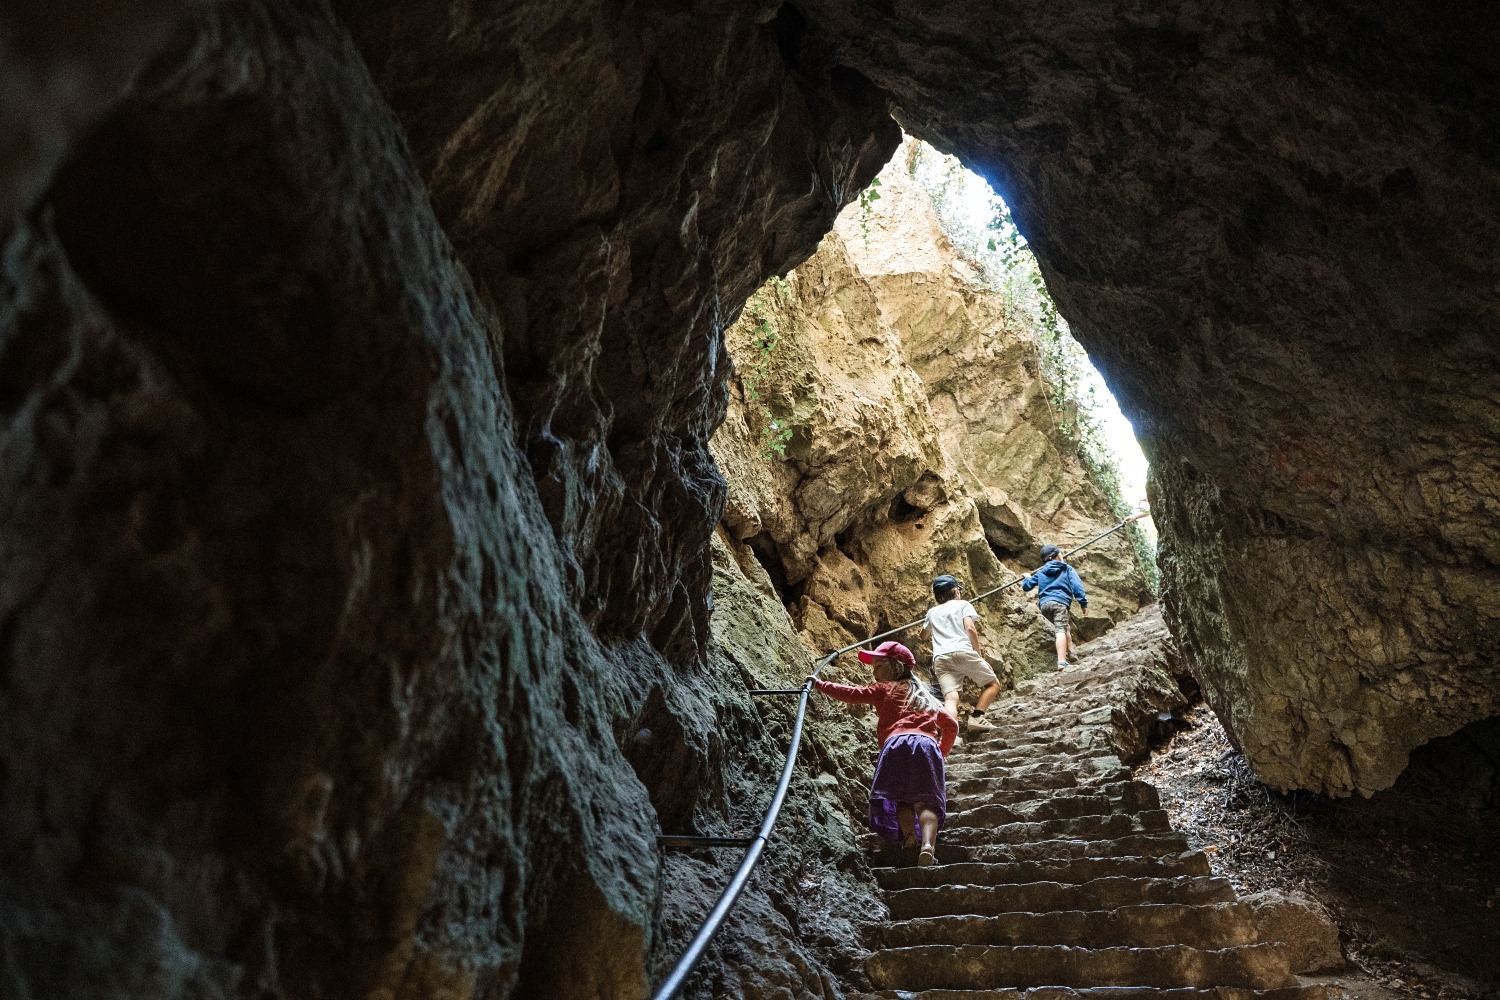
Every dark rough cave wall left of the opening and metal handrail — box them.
[0,0,897,1000]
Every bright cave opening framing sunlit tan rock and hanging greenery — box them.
[713,136,1157,620]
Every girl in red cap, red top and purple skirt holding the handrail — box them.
[810,642,959,867]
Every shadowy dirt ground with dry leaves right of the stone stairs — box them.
[1139,703,1500,1000]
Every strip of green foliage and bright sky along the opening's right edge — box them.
[911,145,1158,592]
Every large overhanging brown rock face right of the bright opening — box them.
[801,0,1500,795]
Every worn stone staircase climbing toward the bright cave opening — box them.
[863,616,1325,1000]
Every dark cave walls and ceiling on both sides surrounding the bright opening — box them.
[0,0,1500,1000]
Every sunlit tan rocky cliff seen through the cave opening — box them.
[714,142,1151,678]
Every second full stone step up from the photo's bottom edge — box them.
[879,903,1257,949]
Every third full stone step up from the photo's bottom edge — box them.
[885,876,1235,921]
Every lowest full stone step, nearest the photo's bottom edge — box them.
[864,945,1295,991]
